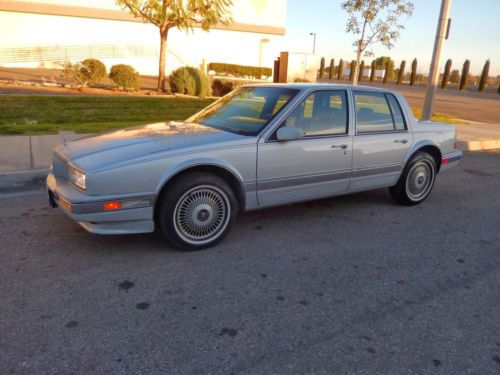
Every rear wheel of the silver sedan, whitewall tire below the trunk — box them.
[389,152,436,206]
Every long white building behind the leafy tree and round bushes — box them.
[0,0,287,75]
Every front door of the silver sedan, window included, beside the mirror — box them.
[257,90,352,206]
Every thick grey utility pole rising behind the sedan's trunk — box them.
[422,0,451,120]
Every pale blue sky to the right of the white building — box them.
[286,0,500,76]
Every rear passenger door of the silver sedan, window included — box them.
[349,90,413,191]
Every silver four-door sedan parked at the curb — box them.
[47,84,462,250]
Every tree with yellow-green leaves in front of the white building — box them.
[116,0,233,91]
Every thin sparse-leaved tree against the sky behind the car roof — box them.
[342,0,414,85]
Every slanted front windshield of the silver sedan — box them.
[187,87,299,135]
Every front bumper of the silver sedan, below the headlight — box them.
[47,173,156,234]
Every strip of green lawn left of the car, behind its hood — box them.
[0,96,213,135]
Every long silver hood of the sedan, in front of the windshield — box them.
[55,121,252,170]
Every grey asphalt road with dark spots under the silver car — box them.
[0,152,500,374]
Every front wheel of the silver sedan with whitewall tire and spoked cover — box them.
[156,172,238,251]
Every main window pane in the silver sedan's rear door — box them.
[354,92,394,134]
